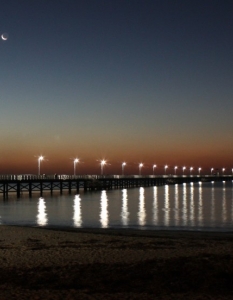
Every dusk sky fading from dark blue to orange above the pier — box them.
[0,0,233,174]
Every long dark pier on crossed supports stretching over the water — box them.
[0,175,233,198]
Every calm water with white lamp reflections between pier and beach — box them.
[0,182,233,231]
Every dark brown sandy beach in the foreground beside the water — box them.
[0,226,233,300]
